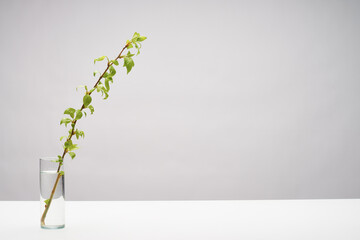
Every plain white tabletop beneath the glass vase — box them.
[0,199,360,240]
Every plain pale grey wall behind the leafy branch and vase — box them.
[0,0,360,200]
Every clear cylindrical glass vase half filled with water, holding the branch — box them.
[40,157,65,229]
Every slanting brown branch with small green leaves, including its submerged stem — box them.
[41,32,146,226]
